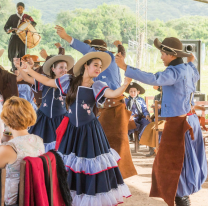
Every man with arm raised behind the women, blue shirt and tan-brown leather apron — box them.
[56,26,137,179]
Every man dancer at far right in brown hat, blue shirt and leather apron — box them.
[116,37,207,206]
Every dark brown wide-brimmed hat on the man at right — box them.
[154,37,191,57]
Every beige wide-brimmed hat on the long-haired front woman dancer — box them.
[73,52,112,77]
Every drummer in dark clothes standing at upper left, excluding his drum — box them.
[4,2,36,70]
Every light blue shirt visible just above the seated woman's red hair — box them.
[17,84,38,111]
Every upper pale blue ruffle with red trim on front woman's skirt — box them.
[44,142,121,175]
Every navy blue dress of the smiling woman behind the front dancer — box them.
[29,80,67,147]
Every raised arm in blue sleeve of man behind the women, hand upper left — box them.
[55,25,92,55]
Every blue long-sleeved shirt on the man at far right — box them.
[125,62,199,117]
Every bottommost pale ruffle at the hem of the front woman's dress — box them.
[71,184,131,206]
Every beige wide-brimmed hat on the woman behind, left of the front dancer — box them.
[43,55,74,75]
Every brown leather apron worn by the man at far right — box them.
[150,116,194,206]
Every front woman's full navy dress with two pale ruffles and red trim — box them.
[47,74,131,206]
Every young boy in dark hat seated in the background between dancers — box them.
[125,82,151,141]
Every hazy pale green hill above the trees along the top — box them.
[13,0,208,23]
